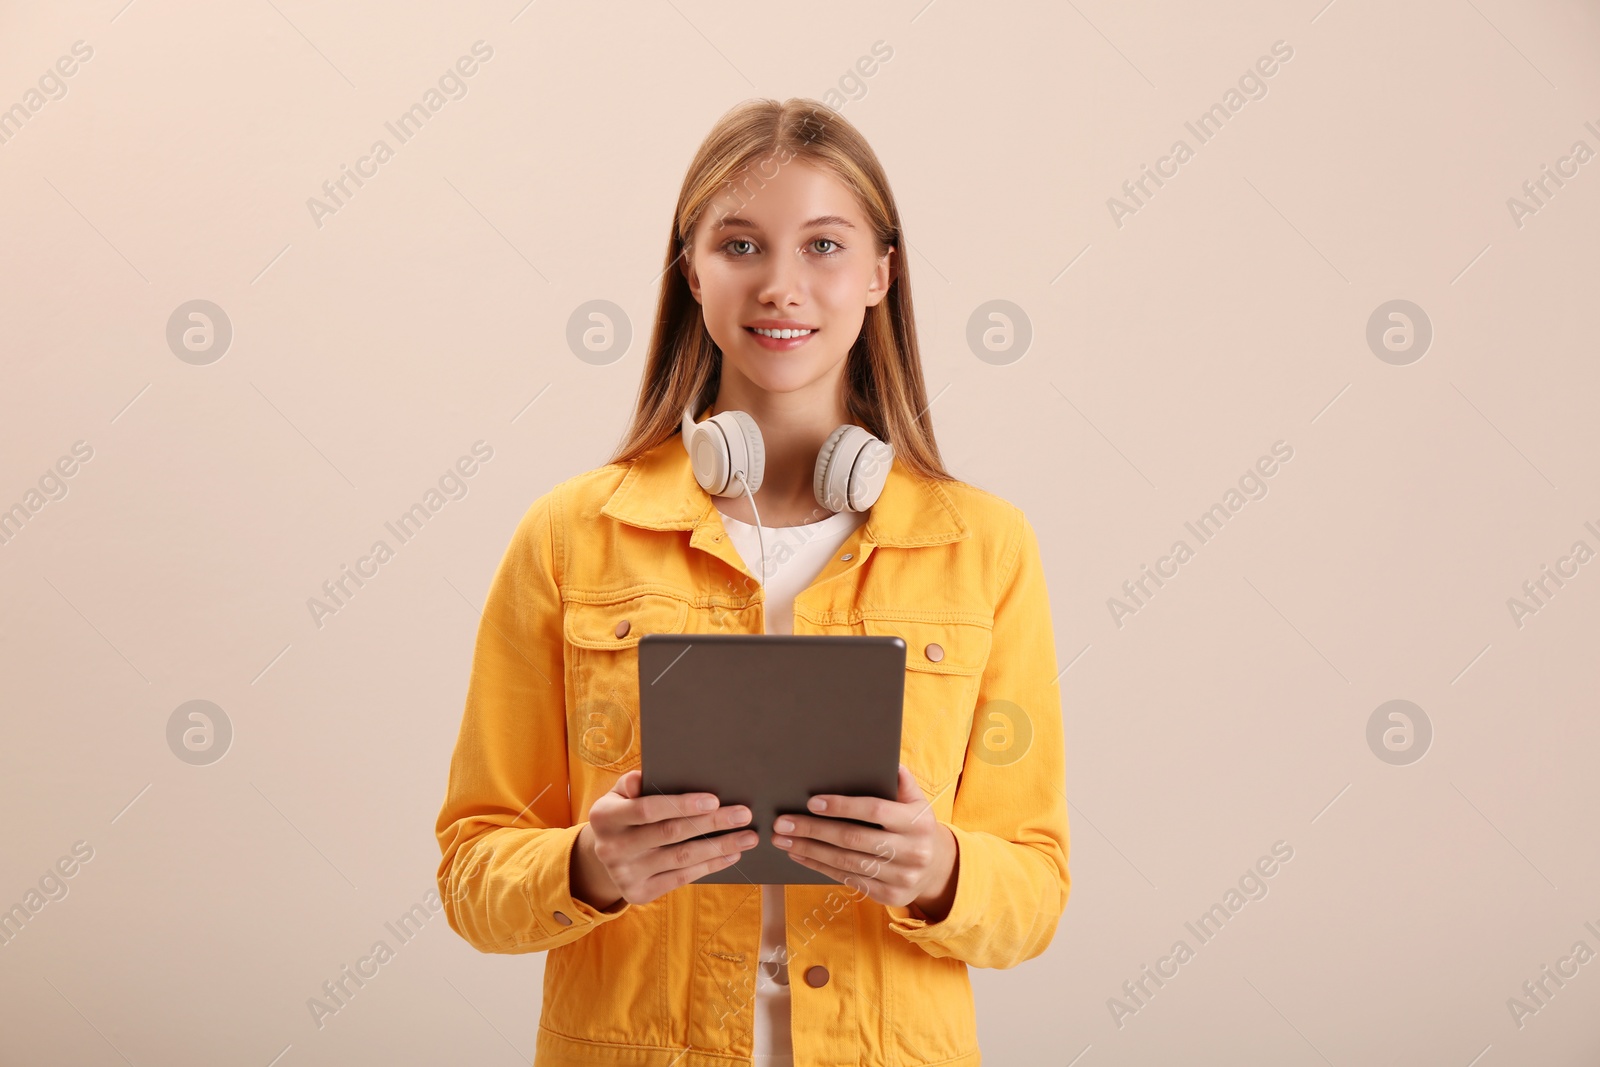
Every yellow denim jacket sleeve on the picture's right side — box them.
[888,512,1072,968]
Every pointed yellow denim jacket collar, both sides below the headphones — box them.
[600,415,971,547]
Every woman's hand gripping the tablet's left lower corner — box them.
[573,768,758,907]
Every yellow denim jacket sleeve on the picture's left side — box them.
[435,490,632,952]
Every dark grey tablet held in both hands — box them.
[638,633,906,885]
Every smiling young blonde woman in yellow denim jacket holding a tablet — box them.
[437,99,1070,1067]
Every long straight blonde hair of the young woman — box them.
[608,98,955,482]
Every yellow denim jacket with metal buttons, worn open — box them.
[437,422,1070,1067]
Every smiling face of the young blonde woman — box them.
[683,158,893,403]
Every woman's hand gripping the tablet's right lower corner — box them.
[773,763,957,918]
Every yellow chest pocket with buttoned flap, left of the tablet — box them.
[562,593,690,774]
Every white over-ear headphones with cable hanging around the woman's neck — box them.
[683,406,894,582]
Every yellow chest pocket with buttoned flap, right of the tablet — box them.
[862,617,992,814]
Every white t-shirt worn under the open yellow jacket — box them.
[717,507,867,1067]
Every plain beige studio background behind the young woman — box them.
[0,0,1600,1067]
